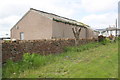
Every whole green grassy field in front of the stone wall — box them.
[3,39,118,78]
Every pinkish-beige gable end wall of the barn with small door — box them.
[11,10,52,40]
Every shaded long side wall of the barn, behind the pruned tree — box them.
[52,21,97,39]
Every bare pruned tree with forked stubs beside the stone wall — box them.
[72,27,81,46]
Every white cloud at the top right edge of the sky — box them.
[81,0,118,12]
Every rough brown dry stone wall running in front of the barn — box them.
[2,39,97,62]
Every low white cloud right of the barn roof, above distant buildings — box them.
[81,13,117,29]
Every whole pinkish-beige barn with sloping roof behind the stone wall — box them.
[11,8,98,40]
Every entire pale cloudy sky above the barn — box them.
[0,0,119,37]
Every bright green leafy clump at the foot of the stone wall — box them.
[23,53,50,68]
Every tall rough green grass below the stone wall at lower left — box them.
[3,53,54,78]
